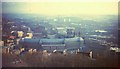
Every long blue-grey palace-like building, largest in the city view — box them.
[19,37,83,51]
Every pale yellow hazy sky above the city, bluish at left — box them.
[2,2,118,15]
